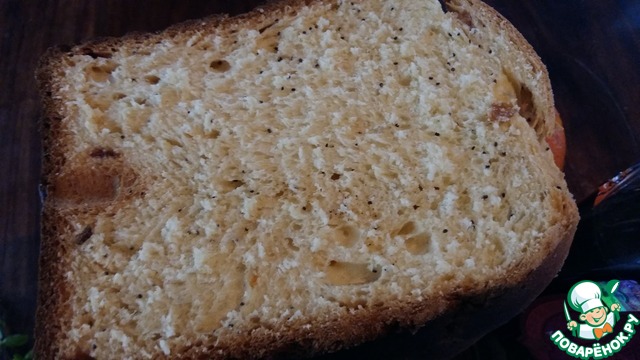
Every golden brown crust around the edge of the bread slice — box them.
[36,0,577,359]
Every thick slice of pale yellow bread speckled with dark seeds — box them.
[36,0,578,359]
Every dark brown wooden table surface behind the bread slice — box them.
[0,0,640,358]
